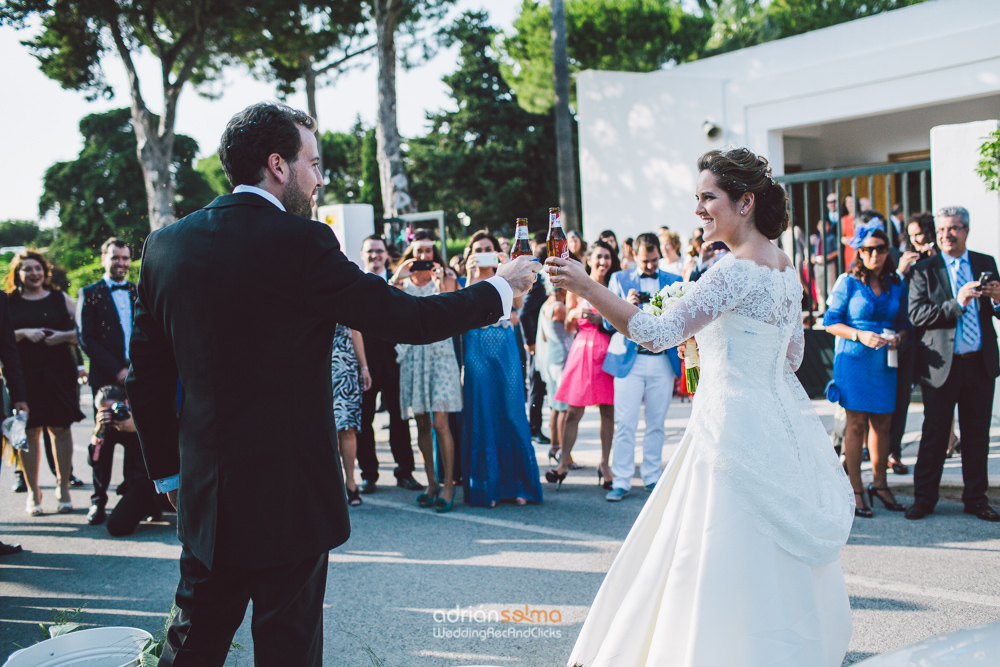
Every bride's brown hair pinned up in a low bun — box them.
[698,148,788,240]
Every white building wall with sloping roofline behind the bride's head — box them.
[577,0,1000,244]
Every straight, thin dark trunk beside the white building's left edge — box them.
[552,0,580,231]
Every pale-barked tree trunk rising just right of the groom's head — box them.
[372,0,413,217]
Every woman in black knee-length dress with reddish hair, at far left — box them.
[7,250,84,516]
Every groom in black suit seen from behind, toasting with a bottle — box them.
[126,103,541,667]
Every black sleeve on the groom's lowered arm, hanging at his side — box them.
[125,243,181,480]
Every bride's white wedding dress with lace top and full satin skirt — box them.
[568,255,854,667]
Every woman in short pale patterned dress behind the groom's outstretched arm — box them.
[389,233,462,512]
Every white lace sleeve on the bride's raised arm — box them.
[628,259,750,352]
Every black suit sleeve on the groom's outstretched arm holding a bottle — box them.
[298,223,503,344]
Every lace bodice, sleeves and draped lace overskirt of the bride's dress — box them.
[629,255,854,566]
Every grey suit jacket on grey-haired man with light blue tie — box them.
[909,250,1000,387]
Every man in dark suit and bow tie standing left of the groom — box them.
[76,237,136,526]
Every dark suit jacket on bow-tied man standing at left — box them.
[76,278,136,389]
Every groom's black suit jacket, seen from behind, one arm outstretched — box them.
[126,193,502,568]
